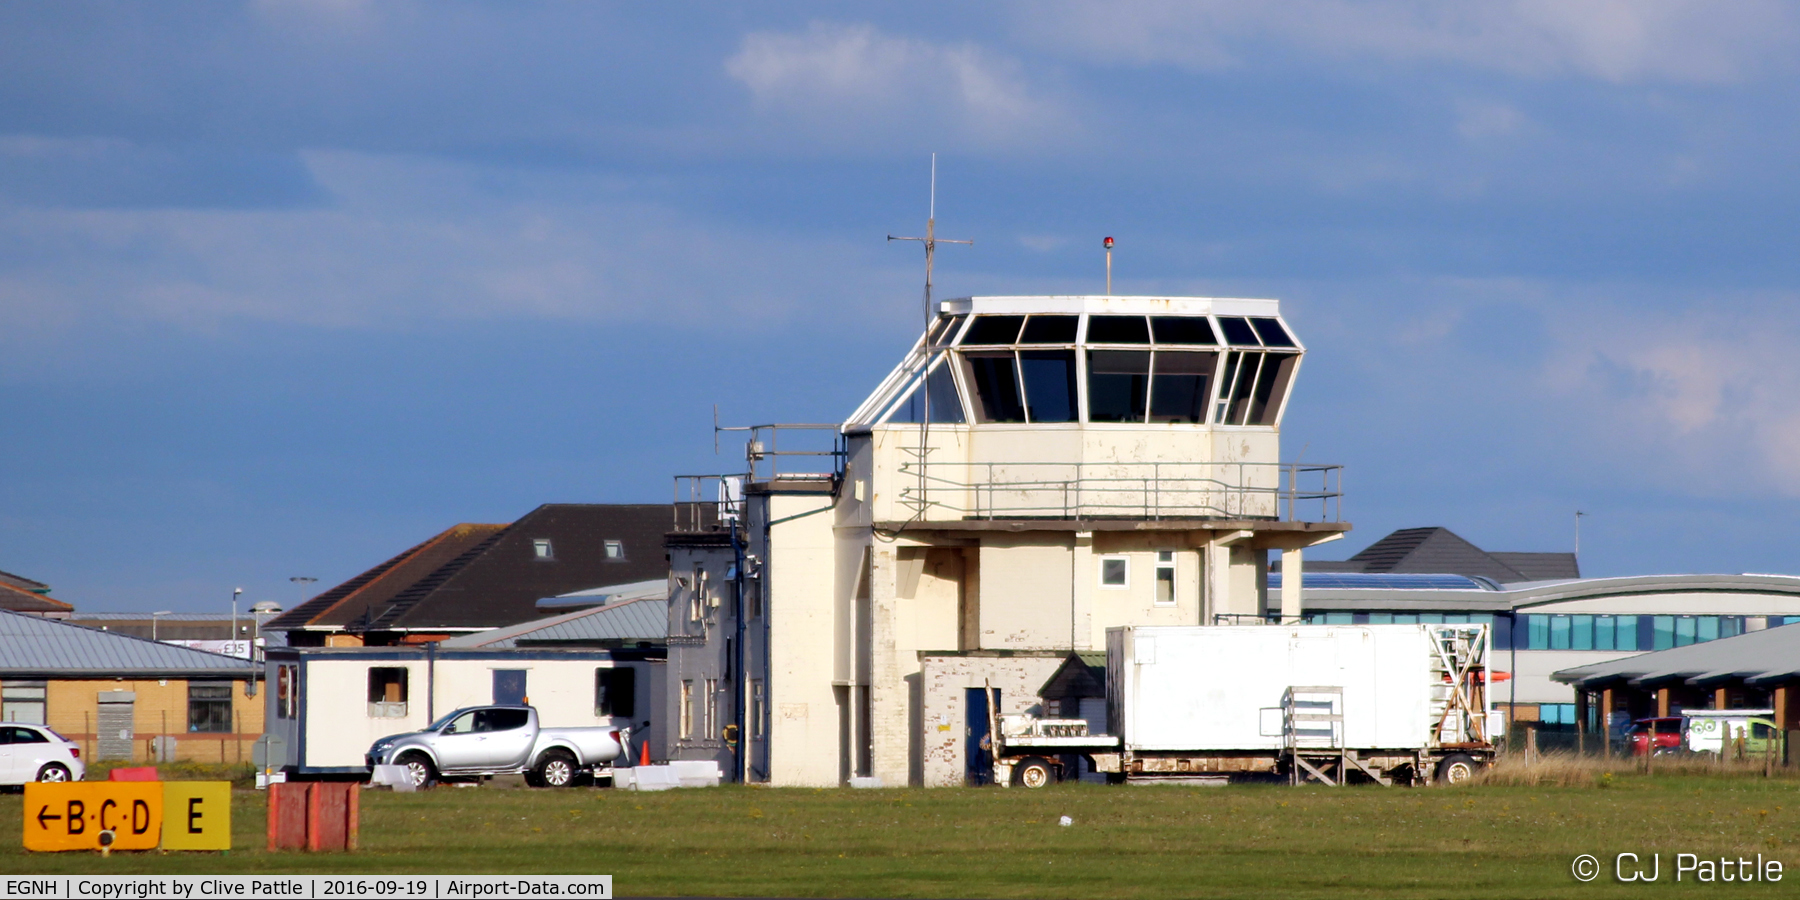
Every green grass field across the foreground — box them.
[0,767,1800,898]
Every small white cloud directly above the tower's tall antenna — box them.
[725,22,1066,146]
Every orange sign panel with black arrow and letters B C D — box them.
[25,781,162,850]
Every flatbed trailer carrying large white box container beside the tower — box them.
[988,625,1503,787]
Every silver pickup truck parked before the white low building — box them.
[367,706,621,788]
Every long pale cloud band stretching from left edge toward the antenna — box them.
[0,153,914,338]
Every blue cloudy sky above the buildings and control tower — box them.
[0,0,1800,612]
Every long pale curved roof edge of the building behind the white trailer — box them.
[1301,574,1800,612]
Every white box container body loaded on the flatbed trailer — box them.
[1107,625,1485,752]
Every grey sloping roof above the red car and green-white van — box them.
[1550,625,1800,689]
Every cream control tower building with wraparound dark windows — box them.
[664,297,1350,785]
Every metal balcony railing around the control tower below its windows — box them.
[895,461,1343,522]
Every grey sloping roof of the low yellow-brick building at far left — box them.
[0,610,257,679]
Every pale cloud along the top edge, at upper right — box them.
[1017,0,1796,83]
